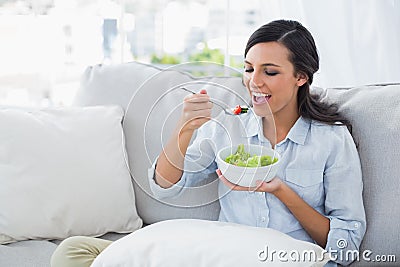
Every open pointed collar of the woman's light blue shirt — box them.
[245,112,311,148]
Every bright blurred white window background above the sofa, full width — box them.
[0,0,400,106]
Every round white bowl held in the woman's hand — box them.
[216,144,281,187]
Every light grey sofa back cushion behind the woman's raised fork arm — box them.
[73,62,248,224]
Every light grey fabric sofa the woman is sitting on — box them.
[0,62,400,267]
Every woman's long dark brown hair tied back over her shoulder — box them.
[244,20,351,130]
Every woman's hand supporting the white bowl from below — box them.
[216,169,284,193]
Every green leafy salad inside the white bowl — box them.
[225,144,278,167]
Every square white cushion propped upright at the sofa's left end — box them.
[0,106,142,244]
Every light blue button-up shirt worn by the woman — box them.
[149,110,366,266]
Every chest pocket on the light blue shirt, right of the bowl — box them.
[285,169,325,208]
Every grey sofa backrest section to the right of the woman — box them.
[315,84,400,266]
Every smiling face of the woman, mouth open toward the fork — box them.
[243,42,307,117]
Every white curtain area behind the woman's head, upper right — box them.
[260,0,400,87]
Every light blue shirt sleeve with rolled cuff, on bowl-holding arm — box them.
[324,127,366,265]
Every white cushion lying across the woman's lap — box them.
[91,219,329,267]
